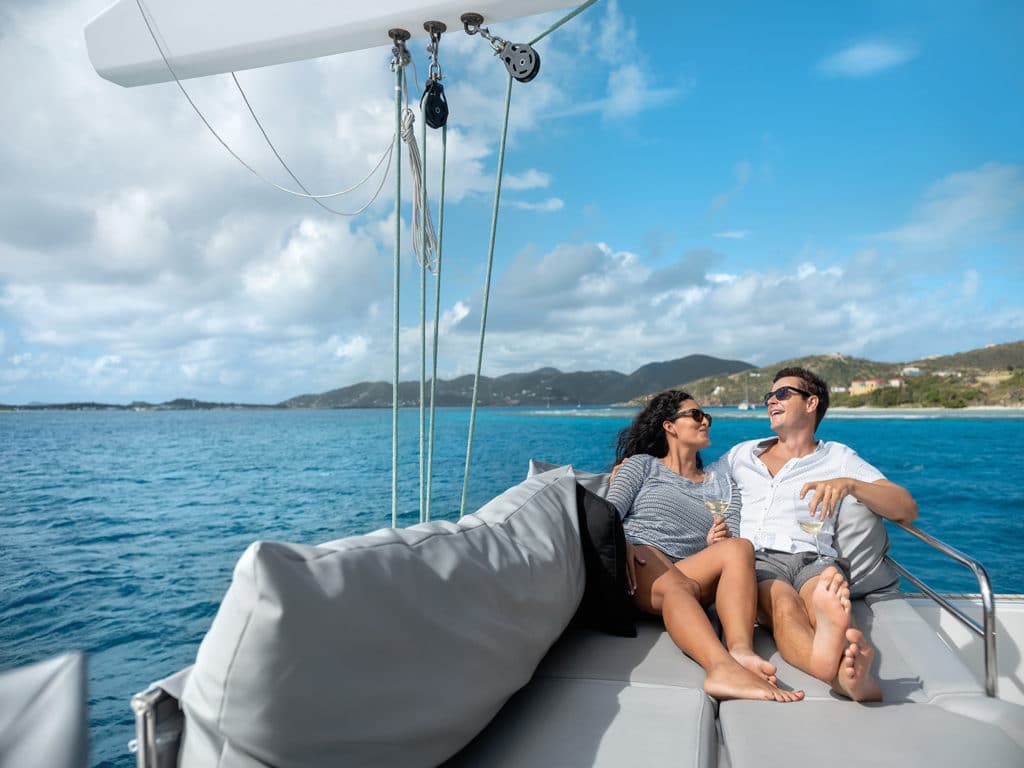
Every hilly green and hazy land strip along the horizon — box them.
[8,341,1024,411]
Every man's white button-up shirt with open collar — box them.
[725,437,885,557]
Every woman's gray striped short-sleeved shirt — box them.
[608,454,740,560]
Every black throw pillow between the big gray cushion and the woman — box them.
[574,483,637,637]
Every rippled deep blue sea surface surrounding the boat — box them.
[0,409,1024,768]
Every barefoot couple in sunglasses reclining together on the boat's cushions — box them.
[608,368,918,701]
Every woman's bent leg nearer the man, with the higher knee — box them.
[675,539,776,683]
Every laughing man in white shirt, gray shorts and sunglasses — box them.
[727,368,918,701]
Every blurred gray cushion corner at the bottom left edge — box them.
[0,653,89,768]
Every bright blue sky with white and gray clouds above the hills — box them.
[0,0,1024,404]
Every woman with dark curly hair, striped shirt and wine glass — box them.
[608,389,804,701]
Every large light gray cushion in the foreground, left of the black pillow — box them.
[180,473,584,768]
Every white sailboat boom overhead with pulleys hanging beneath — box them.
[85,0,573,86]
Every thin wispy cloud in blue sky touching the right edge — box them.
[878,163,1024,250]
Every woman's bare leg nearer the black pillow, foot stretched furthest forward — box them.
[635,545,804,701]
